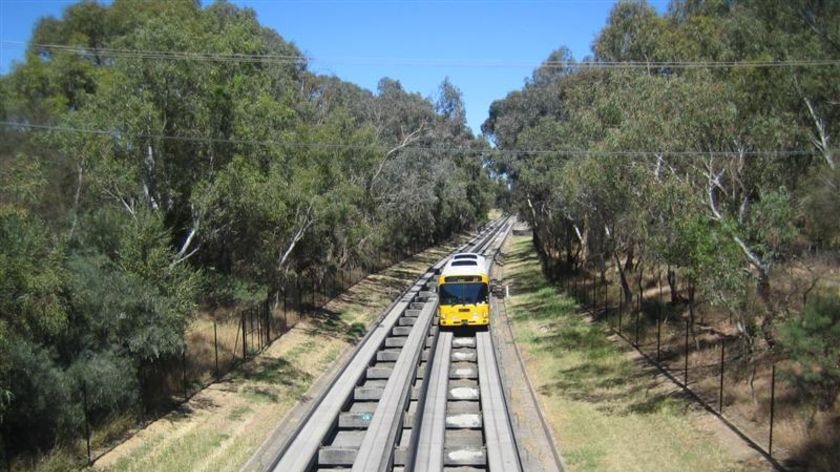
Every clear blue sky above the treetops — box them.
[0,0,668,133]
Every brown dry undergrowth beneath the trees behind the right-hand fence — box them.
[557,245,840,472]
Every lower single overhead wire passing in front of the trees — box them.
[0,121,817,157]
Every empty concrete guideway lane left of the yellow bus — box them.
[244,221,509,472]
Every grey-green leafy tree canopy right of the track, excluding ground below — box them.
[482,0,840,414]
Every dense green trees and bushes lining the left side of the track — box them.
[0,0,494,460]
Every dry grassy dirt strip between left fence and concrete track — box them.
[94,240,472,472]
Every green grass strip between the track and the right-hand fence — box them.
[505,237,742,472]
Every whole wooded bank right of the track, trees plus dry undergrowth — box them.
[482,0,840,471]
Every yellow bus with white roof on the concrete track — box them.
[438,253,490,326]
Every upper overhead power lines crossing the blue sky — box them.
[0,40,840,69]
